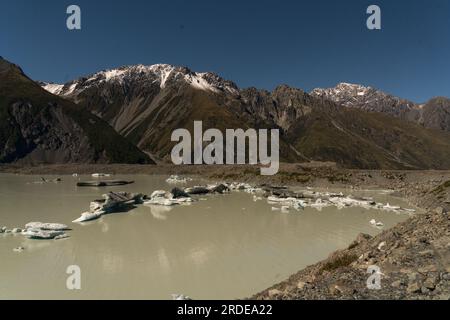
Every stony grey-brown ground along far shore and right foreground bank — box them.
[0,164,450,300]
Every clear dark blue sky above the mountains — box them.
[0,0,450,102]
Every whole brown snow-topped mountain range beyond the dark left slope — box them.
[37,61,450,169]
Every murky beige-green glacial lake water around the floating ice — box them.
[0,174,411,300]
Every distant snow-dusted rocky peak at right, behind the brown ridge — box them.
[311,82,418,117]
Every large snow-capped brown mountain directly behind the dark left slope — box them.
[40,64,251,161]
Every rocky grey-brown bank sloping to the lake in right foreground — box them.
[251,171,450,300]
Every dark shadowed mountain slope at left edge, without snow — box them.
[0,58,152,164]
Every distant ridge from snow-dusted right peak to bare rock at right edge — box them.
[311,83,450,132]
